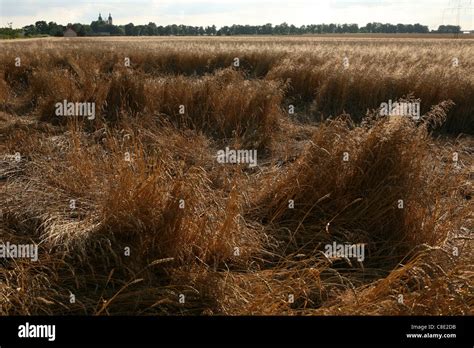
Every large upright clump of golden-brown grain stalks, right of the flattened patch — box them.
[253,105,461,267]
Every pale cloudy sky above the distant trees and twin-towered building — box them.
[0,0,474,29]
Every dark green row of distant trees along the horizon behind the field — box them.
[0,21,461,37]
